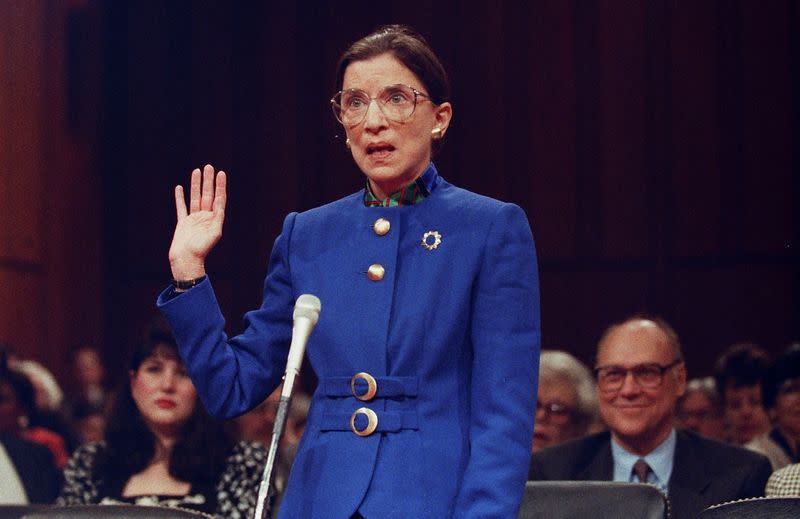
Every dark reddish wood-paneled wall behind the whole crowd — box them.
[0,0,800,388]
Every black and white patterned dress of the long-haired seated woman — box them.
[56,441,267,519]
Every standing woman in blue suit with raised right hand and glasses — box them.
[158,26,540,519]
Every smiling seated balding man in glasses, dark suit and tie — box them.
[529,317,771,519]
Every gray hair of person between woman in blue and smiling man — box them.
[539,350,598,425]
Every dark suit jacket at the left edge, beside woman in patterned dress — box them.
[0,434,61,504]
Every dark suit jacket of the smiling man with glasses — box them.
[528,430,772,519]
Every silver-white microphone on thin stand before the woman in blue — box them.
[253,294,322,519]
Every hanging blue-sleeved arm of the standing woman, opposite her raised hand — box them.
[454,204,541,519]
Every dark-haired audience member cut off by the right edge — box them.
[746,344,800,470]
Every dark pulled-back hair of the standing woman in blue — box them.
[335,25,450,105]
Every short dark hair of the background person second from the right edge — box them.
[714,342,769,403]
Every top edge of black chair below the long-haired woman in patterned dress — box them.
[20,505,213,519]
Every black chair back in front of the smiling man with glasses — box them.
[519,481,670,519]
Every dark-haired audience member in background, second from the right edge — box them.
[714,343,770,445]
